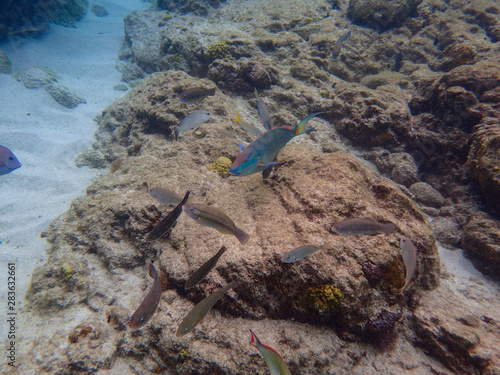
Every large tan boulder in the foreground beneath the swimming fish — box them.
[15,72,440,375]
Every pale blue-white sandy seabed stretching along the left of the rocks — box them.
[0,0,146,324]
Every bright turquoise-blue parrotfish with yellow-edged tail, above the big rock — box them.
[229,112,321,176]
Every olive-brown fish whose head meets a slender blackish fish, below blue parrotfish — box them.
[182,204,250,245]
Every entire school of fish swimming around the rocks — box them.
[128,39,417,375]
